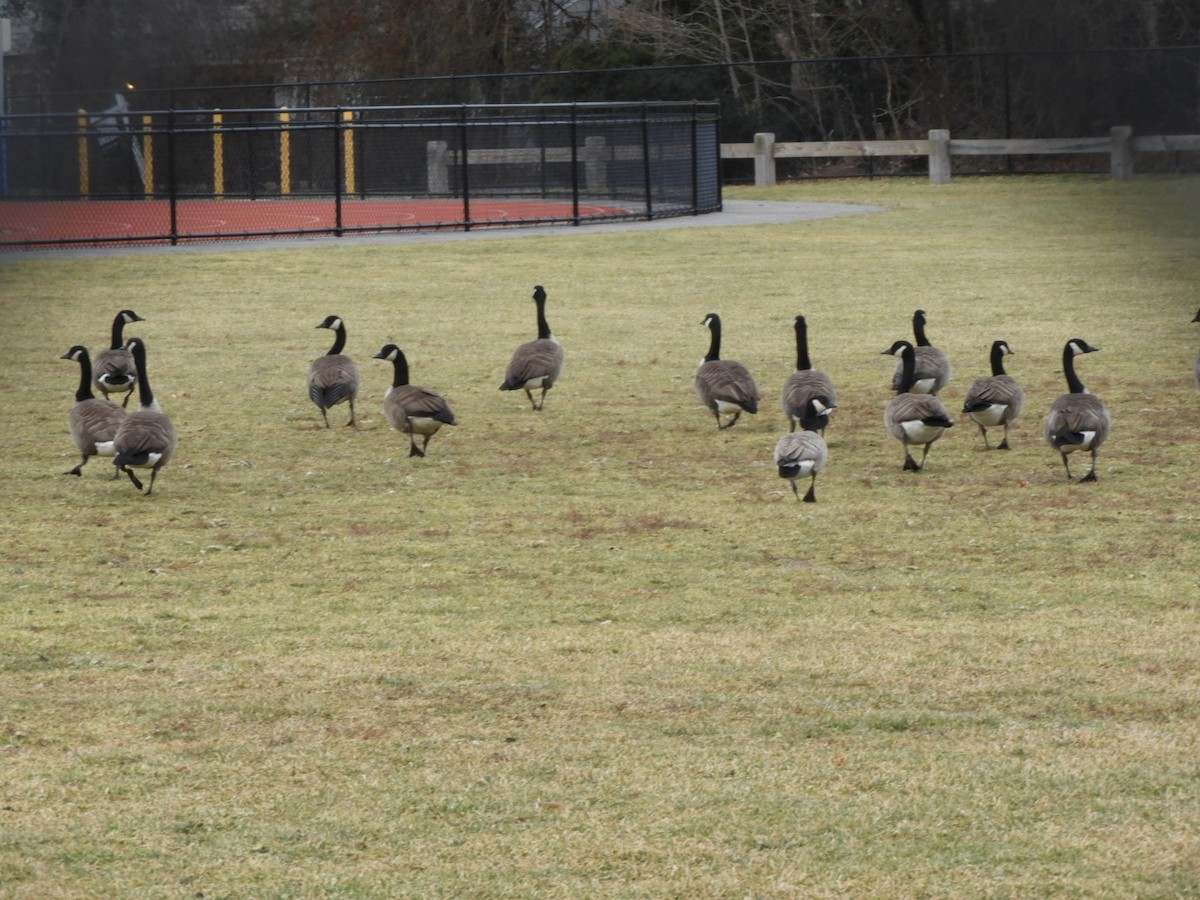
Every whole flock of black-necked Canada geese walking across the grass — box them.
[62,294,1200,503]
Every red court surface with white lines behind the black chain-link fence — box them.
[0,199,630,247]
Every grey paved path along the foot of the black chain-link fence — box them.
[0,200,884,264]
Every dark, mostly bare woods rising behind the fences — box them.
[7,0,1200,140]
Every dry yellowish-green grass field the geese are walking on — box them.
[0,176,1200,898]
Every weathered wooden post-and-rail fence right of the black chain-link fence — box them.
[721,125,1200,185]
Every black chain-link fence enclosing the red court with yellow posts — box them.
[0,96,721,247]
